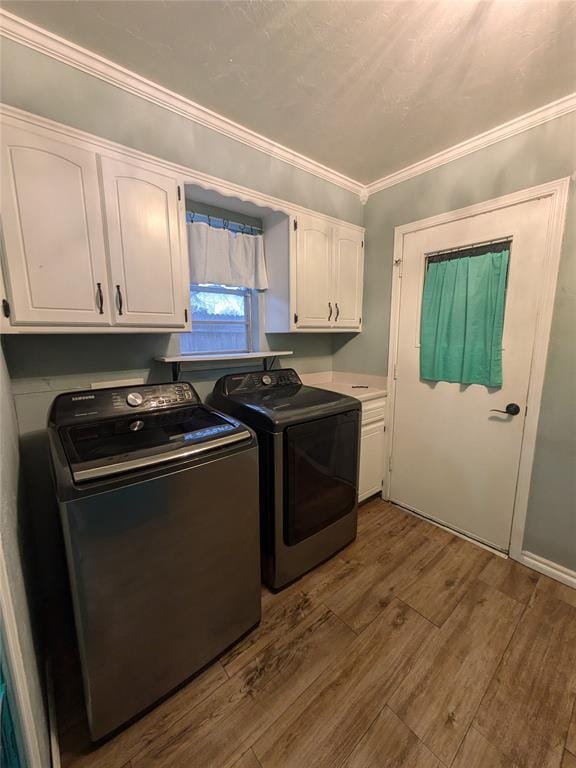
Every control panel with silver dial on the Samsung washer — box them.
[50,381,200,425]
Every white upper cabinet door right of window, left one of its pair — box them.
[295,216,335,328]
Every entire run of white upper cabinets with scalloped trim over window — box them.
[0,105,364,333]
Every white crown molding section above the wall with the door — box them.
[365,93,576,198]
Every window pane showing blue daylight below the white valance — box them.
[180,285,252,354]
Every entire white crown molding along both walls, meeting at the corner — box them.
[0,9,576,204]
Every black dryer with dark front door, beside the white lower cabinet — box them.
[210,369,361,589]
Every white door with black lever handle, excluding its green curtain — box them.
[389,198,550,550]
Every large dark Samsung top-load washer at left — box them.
[48,382,260,740]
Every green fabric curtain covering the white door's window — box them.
[420,247,510,387]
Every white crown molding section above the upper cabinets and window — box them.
[0,9,364,195]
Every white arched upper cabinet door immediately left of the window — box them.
[102,157,187,327]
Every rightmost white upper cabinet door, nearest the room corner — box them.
[334,227,364,329]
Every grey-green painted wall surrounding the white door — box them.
[333,113,576,569]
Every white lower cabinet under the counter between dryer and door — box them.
[358,398,386,501]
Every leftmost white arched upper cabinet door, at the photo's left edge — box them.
[1,125,111,325]
